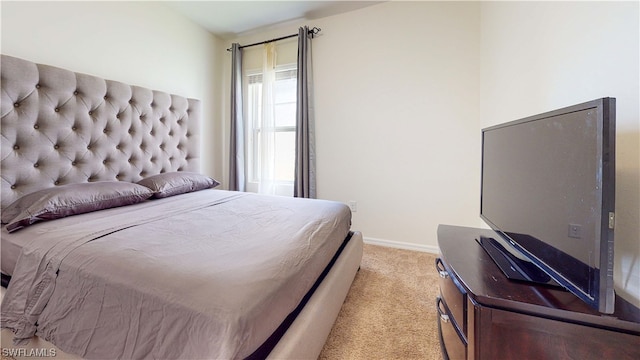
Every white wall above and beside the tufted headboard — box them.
[0,1,224,177]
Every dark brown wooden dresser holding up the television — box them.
[436,225,640,359]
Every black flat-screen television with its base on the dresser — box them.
[476,98,616,314]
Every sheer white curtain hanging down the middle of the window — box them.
[258,42,276,195]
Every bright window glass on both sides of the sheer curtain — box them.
[245,64,297,196]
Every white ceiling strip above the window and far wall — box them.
[164,1,384,39]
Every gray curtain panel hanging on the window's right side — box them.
[293,26,316,199]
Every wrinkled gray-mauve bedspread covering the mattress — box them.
[1,190,351,359]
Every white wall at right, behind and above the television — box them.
[480,2,640,306]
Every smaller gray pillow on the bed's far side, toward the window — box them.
[138,171,220,199]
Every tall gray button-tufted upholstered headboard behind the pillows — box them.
[0,55,200,209]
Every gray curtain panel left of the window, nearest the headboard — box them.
[229,43,245,191]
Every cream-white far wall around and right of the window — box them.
[224,2,480,251]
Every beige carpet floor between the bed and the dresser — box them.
[319,244,442,360]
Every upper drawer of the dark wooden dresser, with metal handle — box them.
[436,258,467,339]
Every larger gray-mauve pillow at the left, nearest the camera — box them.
[2,181,153,232]
